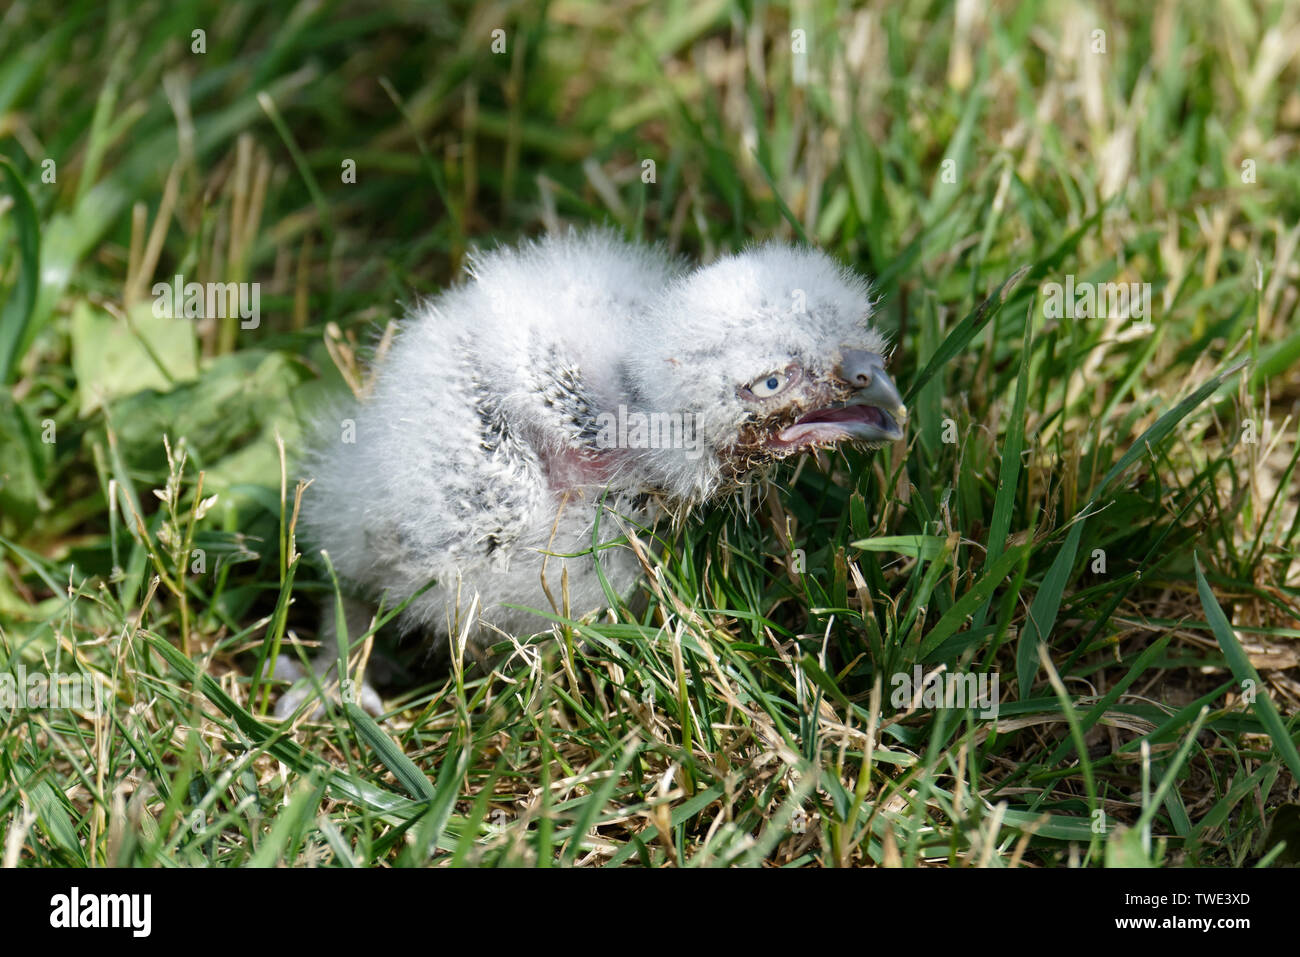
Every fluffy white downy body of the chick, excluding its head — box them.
[303,234,680,637]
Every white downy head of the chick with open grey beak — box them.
[627,243,907,501]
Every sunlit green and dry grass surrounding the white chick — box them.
[0,0,1300,866]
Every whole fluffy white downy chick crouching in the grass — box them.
[277,231,906,715]
